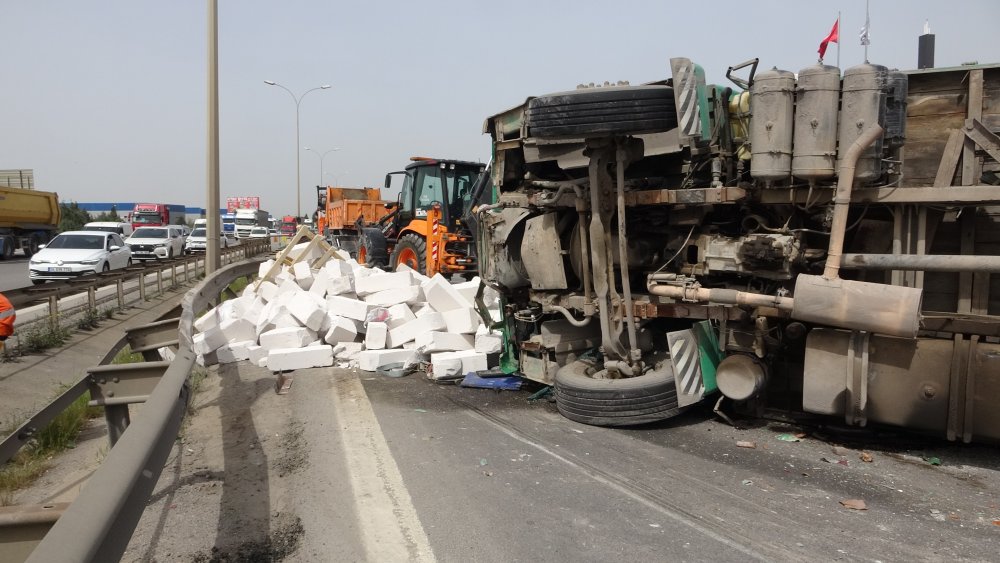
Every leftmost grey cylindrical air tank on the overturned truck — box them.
[750,68,795,183]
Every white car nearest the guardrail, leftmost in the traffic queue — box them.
[28,231,132,284]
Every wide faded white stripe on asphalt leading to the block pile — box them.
[333,375,436,563]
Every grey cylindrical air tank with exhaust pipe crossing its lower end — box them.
[837,63,889,182]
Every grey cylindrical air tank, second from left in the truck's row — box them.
[792,64,840,182]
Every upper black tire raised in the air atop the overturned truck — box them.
[527,86,677,138]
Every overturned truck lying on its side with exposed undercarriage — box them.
[477,58,1000,441]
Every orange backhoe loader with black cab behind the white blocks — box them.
[358,157,485,276]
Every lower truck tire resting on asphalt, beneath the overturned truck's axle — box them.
[555,360,681,426]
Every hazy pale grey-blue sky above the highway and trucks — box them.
[0,0,1000,216]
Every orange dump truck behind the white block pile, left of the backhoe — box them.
[316,186,389,256]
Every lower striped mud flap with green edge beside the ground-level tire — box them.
[667,321,722,407]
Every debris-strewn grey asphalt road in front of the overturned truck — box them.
[105,364,1000,562]
